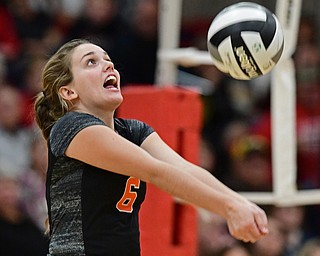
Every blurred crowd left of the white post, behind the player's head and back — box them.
[0,0,158,256]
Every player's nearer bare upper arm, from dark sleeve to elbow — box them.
[65,125,160,181]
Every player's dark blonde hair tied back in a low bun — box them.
[34,39,91,140]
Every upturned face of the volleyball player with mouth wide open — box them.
[60,44,123,114]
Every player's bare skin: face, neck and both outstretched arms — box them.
[59,44,268,243]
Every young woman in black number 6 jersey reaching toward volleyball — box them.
[35,40,268,256]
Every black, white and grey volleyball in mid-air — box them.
[207,2,284,80]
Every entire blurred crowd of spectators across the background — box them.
[0,0,320,256]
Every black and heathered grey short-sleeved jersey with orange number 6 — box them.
[46,112,153,256]
